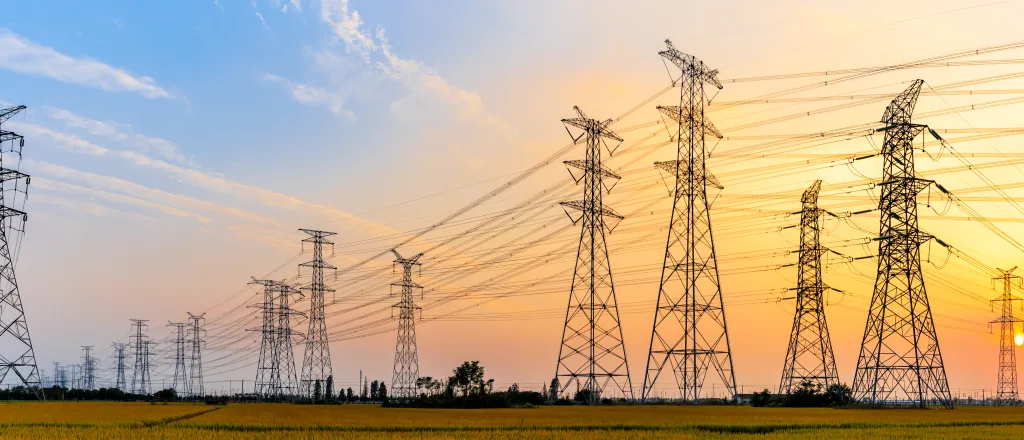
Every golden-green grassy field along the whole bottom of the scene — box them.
[0,402,1024,440]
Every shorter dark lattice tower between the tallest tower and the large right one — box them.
[778,180,839,394]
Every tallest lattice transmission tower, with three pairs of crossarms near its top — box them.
[643,40,736,401]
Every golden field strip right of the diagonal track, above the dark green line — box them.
[182,403,1024,427]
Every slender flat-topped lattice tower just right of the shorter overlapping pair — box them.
[299,229,337,397]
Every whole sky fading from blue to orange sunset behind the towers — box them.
[0,0,1024,394]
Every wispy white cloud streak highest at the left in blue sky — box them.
[0,28,174,98]
